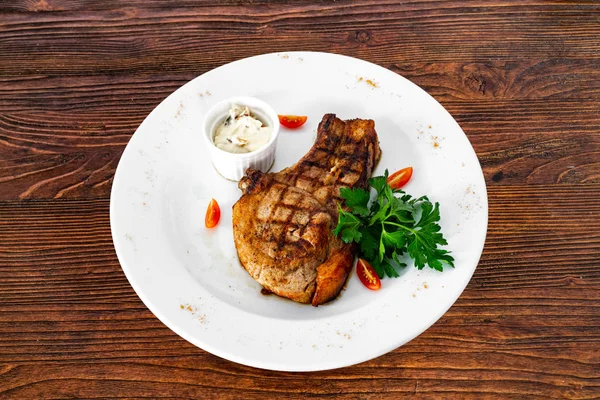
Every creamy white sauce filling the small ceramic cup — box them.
[214,104,273,153]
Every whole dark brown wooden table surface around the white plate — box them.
[0,0,600,399]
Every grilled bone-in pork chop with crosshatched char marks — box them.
[233,114,381,306]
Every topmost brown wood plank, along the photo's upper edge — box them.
[0,1,600,76]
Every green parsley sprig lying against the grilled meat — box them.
[335,170,454,278]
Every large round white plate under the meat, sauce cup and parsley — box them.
[110,52,487,371]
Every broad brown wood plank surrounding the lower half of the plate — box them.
[0,193,600,399]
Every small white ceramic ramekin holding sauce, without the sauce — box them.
[202,96,279,181]
